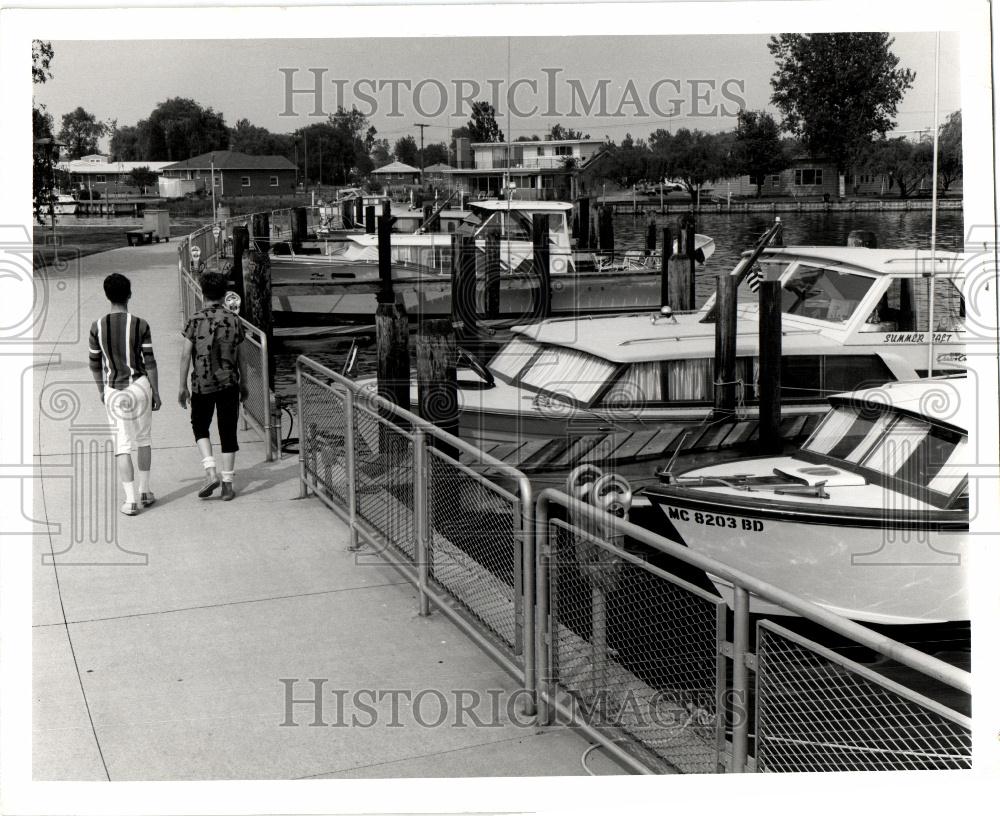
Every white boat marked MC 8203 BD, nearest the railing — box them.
[645,376,973,624]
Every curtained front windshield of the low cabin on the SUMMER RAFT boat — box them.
[489,337,618,403]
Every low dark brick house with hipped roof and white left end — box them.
[160,150,297,198]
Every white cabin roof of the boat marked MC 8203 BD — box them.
[830,374,972,434]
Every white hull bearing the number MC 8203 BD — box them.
[649,488,969,625]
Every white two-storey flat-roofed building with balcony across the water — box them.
[452,139,604,200]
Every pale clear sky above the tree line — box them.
[34,33,961,150]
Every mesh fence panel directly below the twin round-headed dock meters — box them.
[541,520,725,773]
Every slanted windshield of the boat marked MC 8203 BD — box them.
[802,406,968,496]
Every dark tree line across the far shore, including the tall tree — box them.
[32,33,962,199]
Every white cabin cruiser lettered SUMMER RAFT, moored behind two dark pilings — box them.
[444,242,966,446]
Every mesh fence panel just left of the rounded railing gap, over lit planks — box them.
[427,448,522,652]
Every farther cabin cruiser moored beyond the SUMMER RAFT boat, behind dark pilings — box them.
[271,200,715,326]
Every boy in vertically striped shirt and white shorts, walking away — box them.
[90,273,160,516]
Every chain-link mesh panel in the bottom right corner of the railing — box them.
[755,622,972,772]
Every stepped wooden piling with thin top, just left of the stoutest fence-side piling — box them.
[375,212,410,410]
